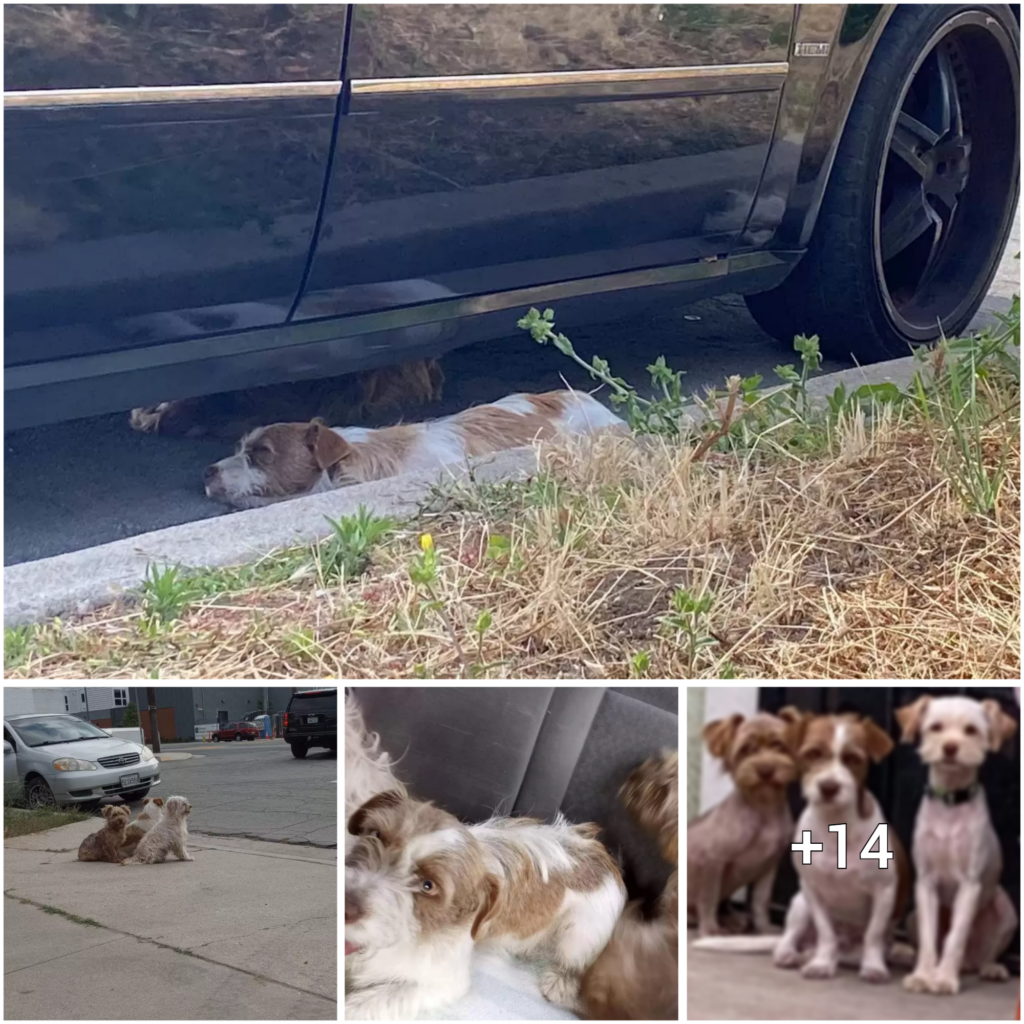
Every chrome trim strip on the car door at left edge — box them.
[3,81,341,111]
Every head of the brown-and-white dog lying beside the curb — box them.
[203,422,352,507]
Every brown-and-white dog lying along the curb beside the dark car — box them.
[203,391,626,508]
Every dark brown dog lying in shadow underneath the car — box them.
[129,359,444,441]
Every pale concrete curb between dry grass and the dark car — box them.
[4,356,921,626]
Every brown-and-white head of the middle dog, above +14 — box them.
[799,715,895,817]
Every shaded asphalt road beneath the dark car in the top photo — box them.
[4,219,1020,569]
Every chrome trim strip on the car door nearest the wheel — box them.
[351,60,790,96]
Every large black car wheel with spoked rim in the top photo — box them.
[746,4,1020,360]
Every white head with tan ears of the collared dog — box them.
[896,696,1017,770]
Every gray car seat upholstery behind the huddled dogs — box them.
[351,686,679,896]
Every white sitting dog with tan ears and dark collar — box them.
[896,696,1017,995]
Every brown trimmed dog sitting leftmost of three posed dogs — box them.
[686,708,802,937]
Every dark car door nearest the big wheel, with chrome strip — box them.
[296,4,794,326]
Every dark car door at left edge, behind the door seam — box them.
[4,4,346,426]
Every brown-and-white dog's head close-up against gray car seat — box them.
[345,791,499,955]
